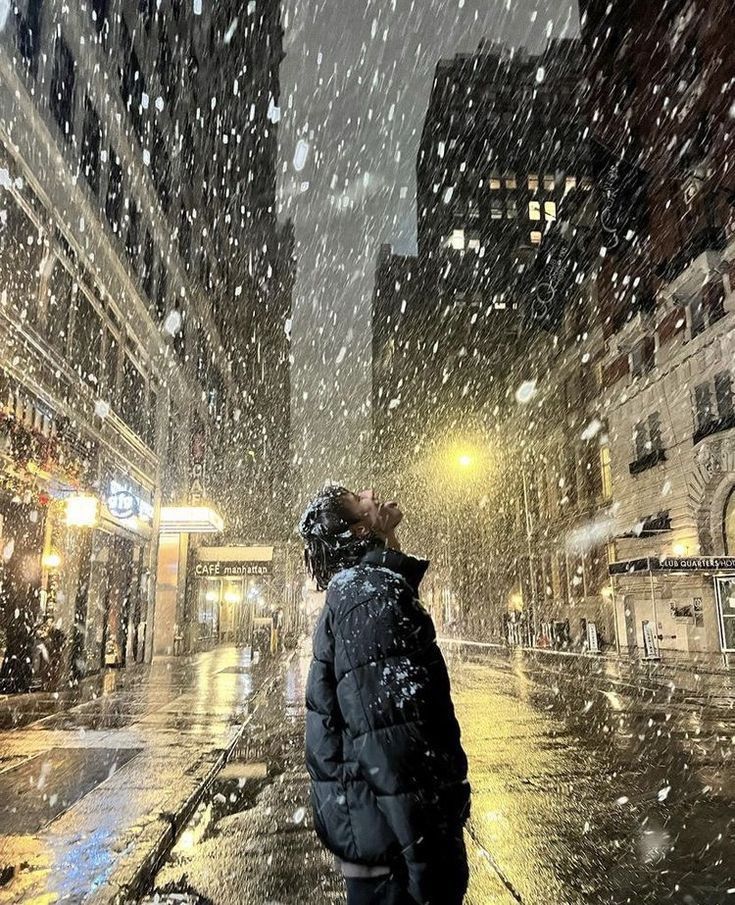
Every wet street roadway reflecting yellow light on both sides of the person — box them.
[146,650,735,905]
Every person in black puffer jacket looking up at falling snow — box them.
[299,486,470,905]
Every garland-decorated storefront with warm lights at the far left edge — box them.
[0,371,97,692]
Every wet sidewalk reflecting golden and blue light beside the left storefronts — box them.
[0,647,284,905]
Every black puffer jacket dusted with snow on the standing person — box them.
[306,549,470,905]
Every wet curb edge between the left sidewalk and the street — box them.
[98,649,296,905]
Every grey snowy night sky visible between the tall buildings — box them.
[280,0,578,493]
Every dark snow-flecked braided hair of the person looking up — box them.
[298,484,383,591]
